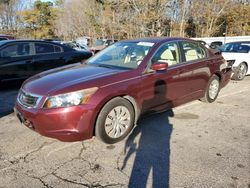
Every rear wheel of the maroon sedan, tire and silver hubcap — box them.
[200,75,220,103]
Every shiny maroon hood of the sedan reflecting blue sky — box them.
[22,64,124,95]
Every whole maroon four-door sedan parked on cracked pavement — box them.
[15,38,231,143]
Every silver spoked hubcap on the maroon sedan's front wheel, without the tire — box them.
[105,106,131,138]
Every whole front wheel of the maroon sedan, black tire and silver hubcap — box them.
[95,97,135,144]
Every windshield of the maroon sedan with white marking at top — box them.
[88,42,154,69]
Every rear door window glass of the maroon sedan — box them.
[182,42,207,61]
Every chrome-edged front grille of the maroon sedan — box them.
[17,90,41,108]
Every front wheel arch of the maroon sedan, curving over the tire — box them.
[93,95,141,136]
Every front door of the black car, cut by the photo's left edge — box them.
[0,42,33,81]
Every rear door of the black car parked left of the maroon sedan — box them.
[34,42,65,73]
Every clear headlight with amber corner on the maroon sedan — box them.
[43,87,98,108]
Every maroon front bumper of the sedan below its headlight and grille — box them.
[15,103,96,142]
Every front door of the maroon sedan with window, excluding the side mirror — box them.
[142,42,191,111]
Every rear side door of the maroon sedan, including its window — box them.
[180,41,214,100]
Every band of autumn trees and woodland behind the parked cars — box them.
[0,0,250,40]
